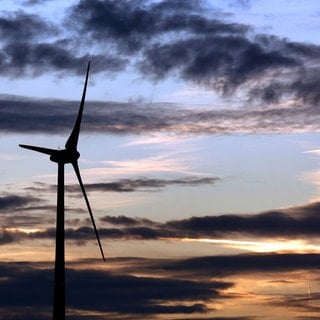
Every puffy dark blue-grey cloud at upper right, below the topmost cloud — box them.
[139,34,320,104]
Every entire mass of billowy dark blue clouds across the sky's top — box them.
[0,0,320,108]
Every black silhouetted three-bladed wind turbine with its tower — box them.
[19,62,105,320]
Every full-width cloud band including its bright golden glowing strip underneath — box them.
[3,201,319,246]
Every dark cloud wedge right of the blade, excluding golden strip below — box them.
[101,203,320,239]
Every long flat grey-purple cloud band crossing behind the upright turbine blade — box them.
[0,95,320,135]
